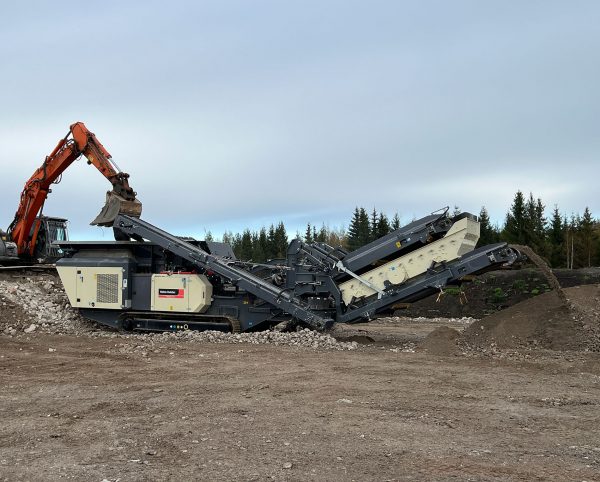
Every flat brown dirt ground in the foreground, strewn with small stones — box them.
[0,333,600,482]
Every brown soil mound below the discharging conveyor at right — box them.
[462,285,600,351]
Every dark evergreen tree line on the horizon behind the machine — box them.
[213,191,600,268]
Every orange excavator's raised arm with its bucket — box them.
[8,122,142,256]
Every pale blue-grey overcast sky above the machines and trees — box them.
[0,0,600,239]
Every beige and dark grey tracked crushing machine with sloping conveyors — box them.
[57,212,520,331]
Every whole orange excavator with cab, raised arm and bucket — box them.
[0,122,142,263]
